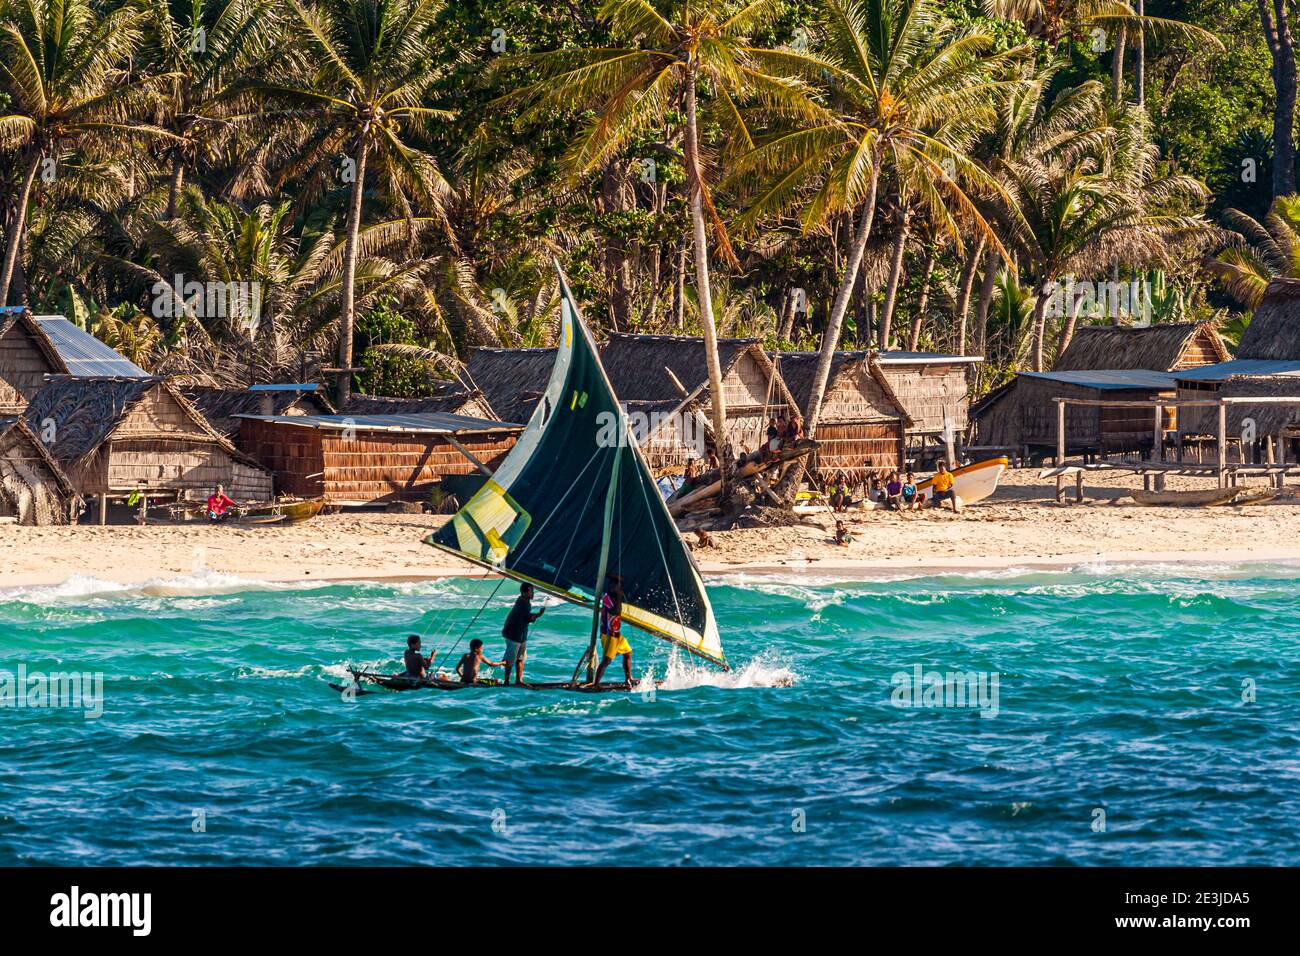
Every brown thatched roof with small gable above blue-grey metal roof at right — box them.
[1053,323,1229,372]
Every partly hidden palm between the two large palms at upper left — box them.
[135,0,278,219]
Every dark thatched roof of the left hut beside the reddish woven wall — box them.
[23,377,263,470]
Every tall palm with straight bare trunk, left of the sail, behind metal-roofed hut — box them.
[239,0,451,407]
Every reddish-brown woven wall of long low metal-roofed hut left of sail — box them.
[239,419,516,505]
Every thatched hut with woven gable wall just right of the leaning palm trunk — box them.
[774,351,911,484]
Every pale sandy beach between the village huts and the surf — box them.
[0,470,1300,587]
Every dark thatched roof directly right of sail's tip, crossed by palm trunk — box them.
[601,332,763,402]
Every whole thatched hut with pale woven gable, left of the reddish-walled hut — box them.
[23,377,272,499]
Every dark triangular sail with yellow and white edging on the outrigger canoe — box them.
[426,261,727,667]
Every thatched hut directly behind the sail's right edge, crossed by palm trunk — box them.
[601,333,794,471]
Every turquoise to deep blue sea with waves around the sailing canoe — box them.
[0,567,1300,865]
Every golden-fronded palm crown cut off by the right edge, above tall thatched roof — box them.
[1205,194,1300,308]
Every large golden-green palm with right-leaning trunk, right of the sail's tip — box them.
[737,0,1022,434]
